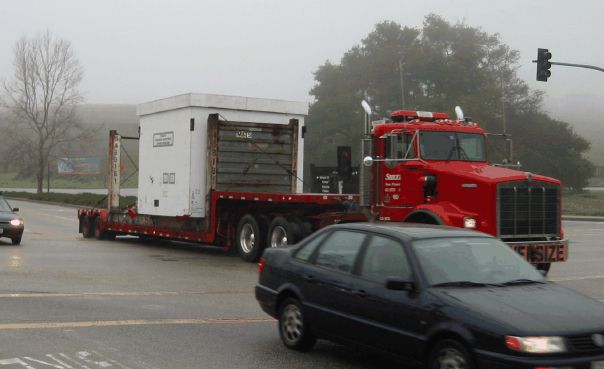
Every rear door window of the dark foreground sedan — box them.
[315,230,366,272]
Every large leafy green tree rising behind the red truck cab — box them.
[306,14,593,188]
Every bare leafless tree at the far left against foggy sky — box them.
[3,31,84,193]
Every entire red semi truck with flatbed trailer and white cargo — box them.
[78,94,568,271]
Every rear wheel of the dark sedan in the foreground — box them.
[279,298,317,351]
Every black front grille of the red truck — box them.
[497,181,560,240]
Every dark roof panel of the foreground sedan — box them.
[329,222,493,241]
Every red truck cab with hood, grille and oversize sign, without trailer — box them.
[366,110,568,271]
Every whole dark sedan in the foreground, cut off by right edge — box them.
[256,223,604,369]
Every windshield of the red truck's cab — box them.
[419,131,486,161]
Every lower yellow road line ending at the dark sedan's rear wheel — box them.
[0,318,275,331]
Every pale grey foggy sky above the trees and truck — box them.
[0,0,604,125]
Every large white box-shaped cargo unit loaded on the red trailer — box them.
[137,93,308,218]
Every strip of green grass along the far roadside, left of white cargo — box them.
[4,191,136,208]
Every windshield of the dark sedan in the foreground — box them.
[412,237,544,286]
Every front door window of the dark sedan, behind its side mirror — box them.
[361,236,411,283]
